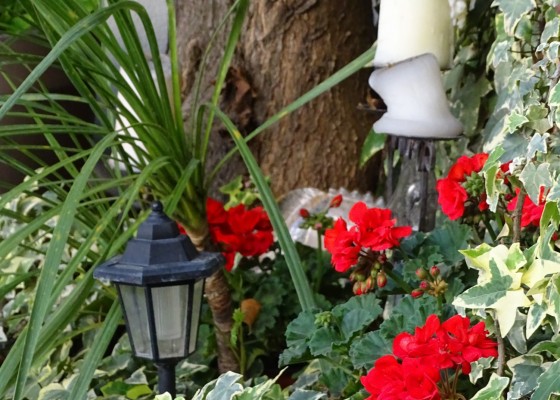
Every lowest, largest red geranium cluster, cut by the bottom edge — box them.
[361,315,498,400]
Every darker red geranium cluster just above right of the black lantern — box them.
[206,198,274,271]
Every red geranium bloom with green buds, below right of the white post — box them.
[436,153,488,220]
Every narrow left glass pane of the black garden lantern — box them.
[119,285,153,359]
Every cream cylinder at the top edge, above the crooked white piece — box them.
[373,0,453,69]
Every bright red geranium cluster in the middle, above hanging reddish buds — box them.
[325,202,412,272]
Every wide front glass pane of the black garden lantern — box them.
[151,285,191,358]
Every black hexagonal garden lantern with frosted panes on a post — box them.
[93,202,223,396]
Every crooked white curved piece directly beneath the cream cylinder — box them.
[369,54,463,139]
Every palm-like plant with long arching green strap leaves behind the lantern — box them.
[0,0,372,400]
